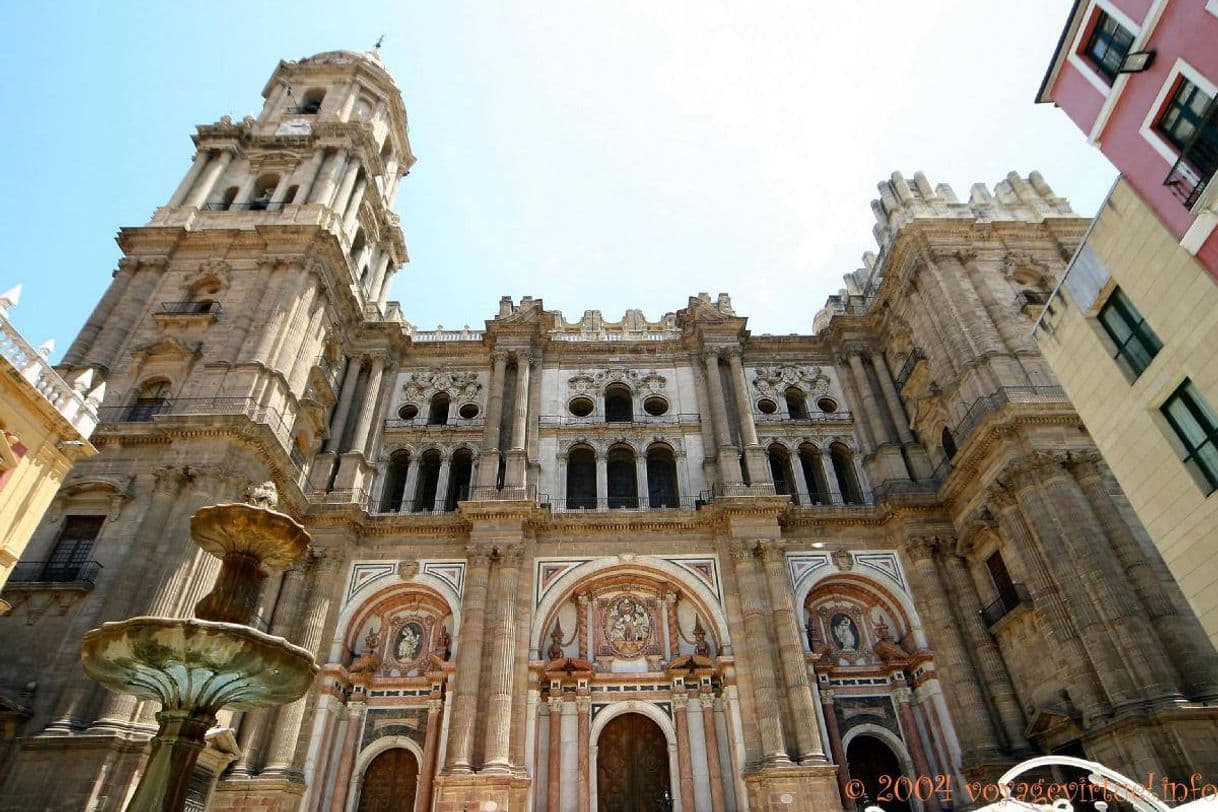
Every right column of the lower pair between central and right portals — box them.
[761,539,825,765]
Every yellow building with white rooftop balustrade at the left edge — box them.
[0,286,105,614]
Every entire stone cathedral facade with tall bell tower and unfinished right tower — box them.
[0,51,1218,812]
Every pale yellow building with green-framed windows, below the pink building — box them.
[1035,179,1218,640]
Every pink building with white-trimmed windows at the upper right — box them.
[1037,0,1218,278]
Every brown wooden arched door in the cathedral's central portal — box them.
[597,713,672,812]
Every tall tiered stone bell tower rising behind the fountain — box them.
[0,51,414,810]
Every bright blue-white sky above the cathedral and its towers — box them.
[0,0,1116,357]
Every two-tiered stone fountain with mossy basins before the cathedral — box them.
[80,483,318,812]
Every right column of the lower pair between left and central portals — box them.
[482,544,524,774]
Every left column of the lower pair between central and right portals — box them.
[730,539,790,767]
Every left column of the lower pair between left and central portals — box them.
[445,544,491,774]
